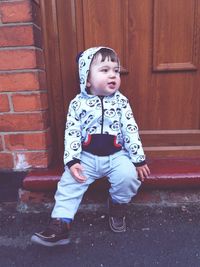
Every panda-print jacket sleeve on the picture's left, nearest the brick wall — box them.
[64,101,82,168]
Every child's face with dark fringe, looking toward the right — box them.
[87,54,121,96]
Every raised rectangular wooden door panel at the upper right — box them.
[153,0,198,71]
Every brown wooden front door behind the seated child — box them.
[41,0,200,166]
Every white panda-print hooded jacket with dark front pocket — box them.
[64,47,146,168]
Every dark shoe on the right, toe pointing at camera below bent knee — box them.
[108,199,127,233]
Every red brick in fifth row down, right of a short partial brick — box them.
[12,93,48,111]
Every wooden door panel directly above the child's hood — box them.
[77,0,128,69]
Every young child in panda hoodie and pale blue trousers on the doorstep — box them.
[31,47,150,246]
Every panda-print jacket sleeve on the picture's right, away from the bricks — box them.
[121,98,146,167]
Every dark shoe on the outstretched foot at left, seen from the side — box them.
[31,219,70,247]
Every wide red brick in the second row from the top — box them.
[0,25,41,47]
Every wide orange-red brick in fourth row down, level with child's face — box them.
[0,71,46,92]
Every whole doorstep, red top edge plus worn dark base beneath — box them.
[18,158,200,212]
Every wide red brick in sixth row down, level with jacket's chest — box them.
[0,112,48,132]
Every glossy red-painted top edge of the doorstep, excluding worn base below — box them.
[23,158,200,192]
